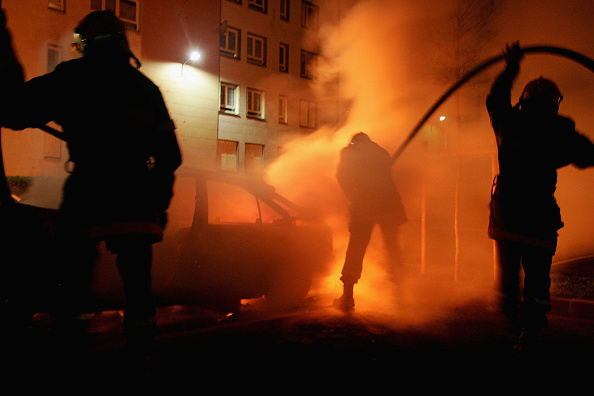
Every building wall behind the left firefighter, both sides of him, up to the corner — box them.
[2,0,220,177]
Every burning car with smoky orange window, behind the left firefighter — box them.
[3,169,332,318]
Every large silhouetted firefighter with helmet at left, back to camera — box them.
[0,11,181,352]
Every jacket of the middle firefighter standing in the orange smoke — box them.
[336,139,406,224]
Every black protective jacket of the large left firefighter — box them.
[0,38,181,246]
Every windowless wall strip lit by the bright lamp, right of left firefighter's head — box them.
[142,0,220,168]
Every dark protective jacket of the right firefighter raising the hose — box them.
[487,67,594,252]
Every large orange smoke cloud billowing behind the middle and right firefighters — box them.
[266,0,594,320]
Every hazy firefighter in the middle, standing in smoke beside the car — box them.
[334,132,406,312]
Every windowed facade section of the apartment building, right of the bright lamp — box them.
[217,0,340,172]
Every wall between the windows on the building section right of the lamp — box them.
[218,0,339,170]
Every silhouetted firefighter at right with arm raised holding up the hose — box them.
[486,43,594,350]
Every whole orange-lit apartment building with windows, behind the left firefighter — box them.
[2,0,340,176]
